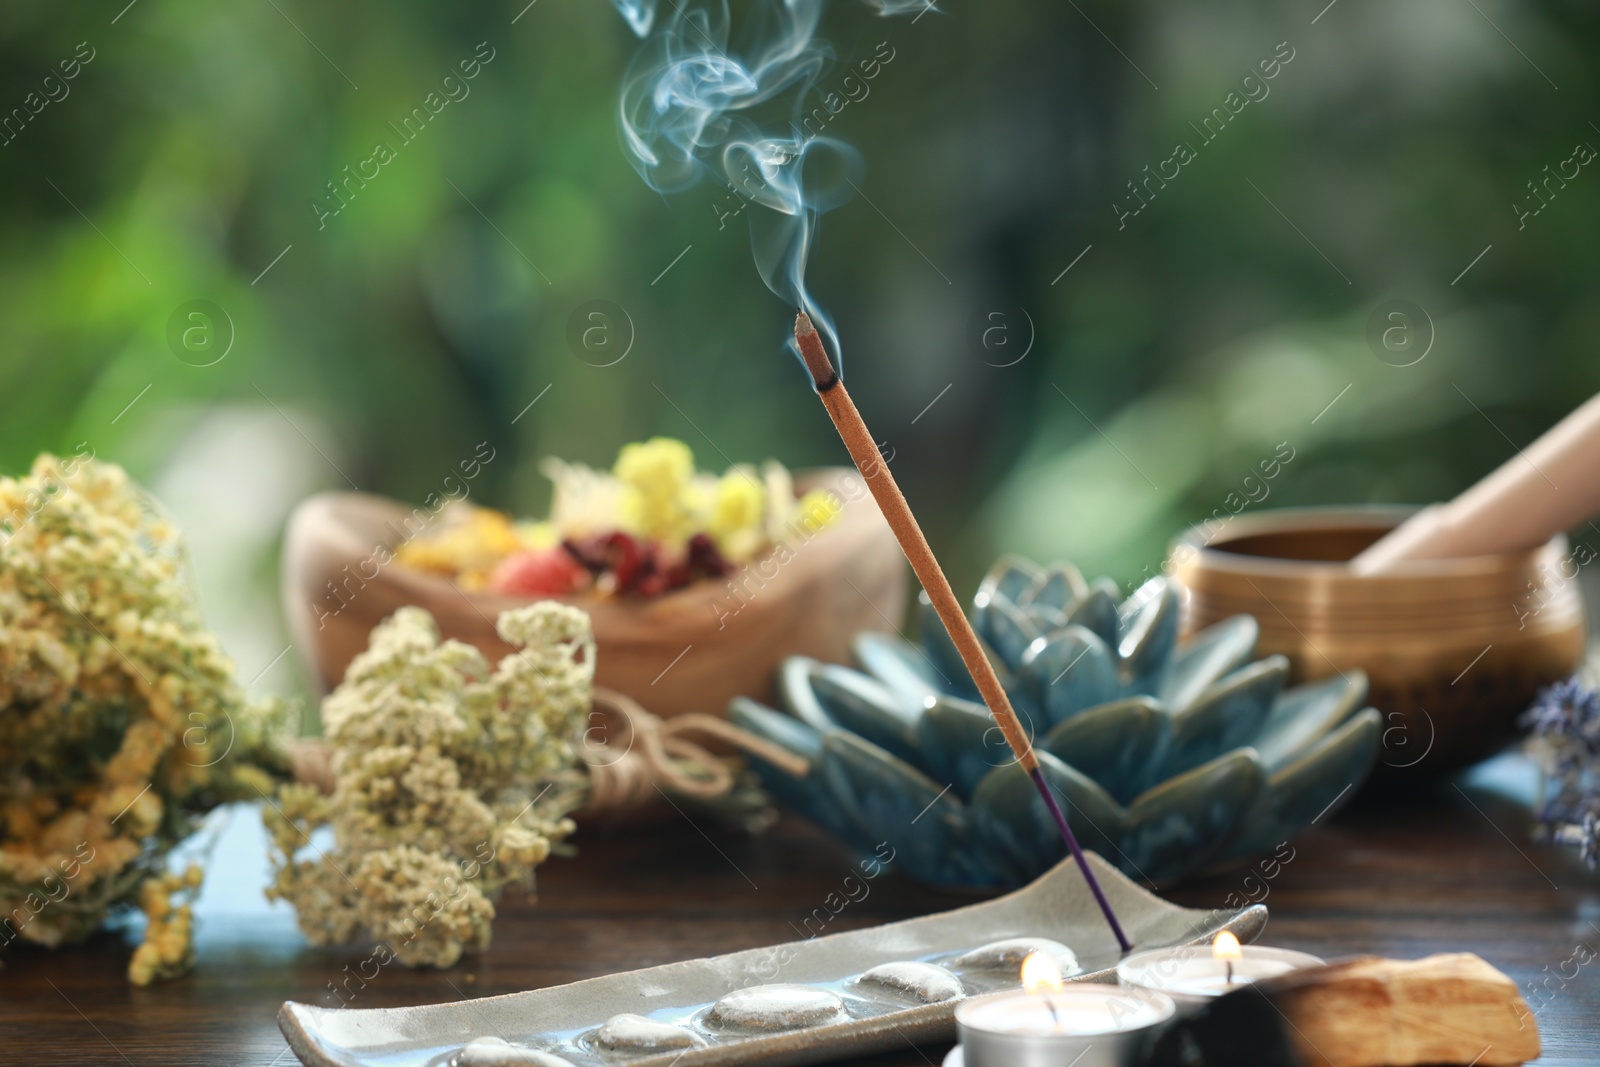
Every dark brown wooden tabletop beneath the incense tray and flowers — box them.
[0,760,1600,1067]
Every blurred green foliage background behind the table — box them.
[0,0,1600,710]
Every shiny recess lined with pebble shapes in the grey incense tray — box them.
[448,937,1083,1067]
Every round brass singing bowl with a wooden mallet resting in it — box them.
[1173,507,1586,776]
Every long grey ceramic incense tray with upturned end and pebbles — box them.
[278,853,1267,1067]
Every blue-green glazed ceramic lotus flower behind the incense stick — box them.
[728,557,1382,886]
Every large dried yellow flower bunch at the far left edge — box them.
[0,450,283,984]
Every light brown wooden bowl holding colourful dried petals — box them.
[283,469,907,715]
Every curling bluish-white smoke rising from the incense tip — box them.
[613,0,931,375]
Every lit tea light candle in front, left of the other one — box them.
[946,952,1176,1067]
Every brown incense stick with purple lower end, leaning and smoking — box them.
[795,310,1133,952]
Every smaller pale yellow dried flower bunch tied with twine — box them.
[266,601,595,966]
